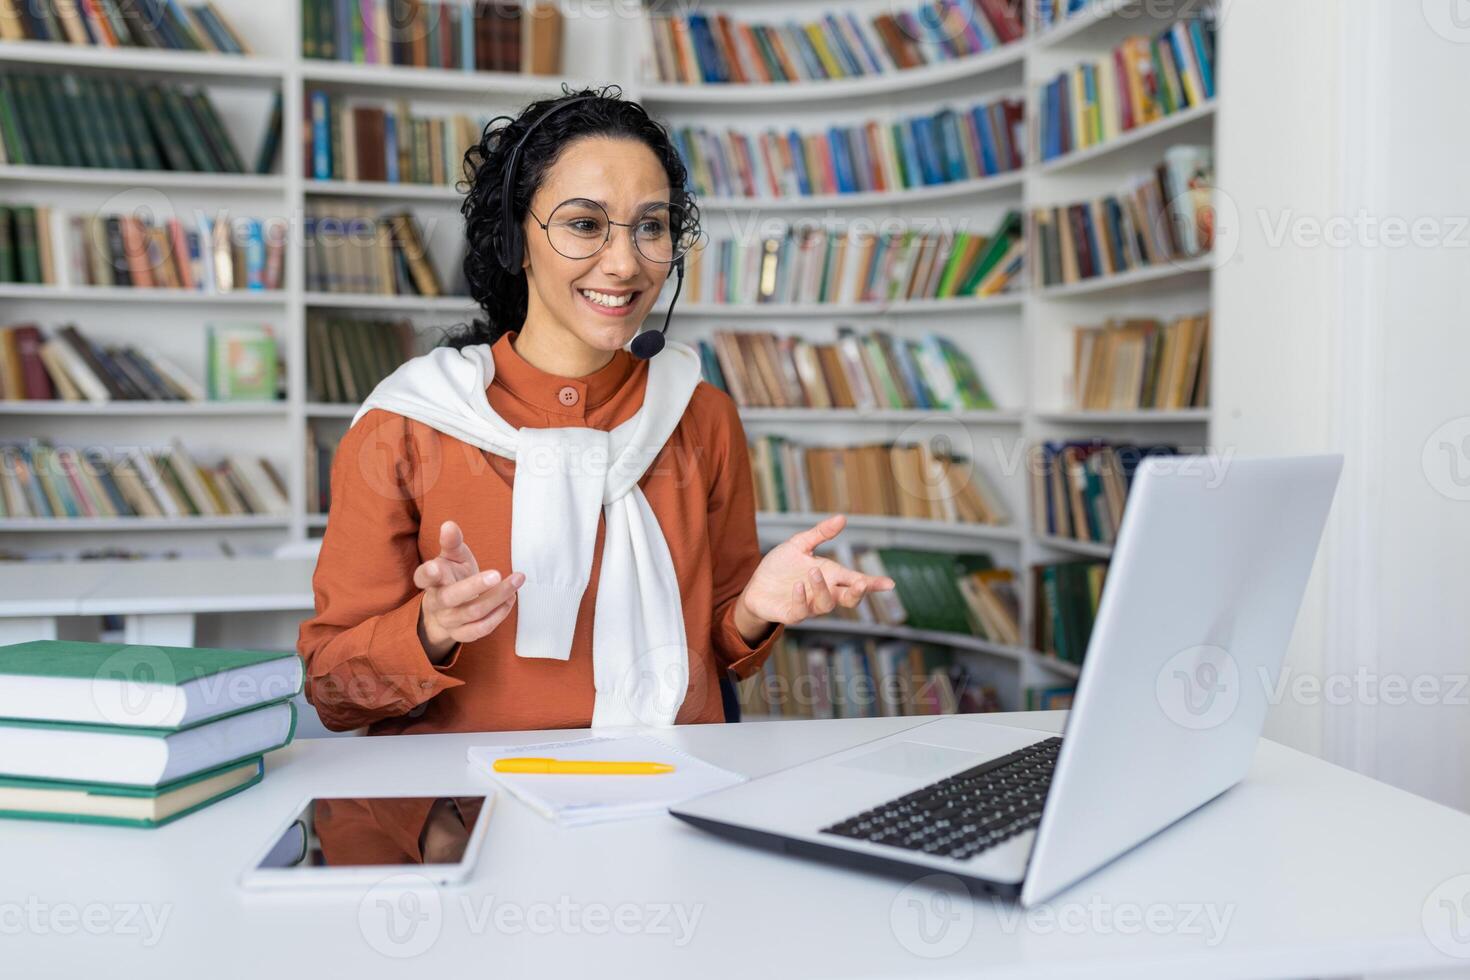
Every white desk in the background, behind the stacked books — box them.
[0,558,316,646]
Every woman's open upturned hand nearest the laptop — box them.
[735,514,894,639]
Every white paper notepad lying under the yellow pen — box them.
[467,735,745,827]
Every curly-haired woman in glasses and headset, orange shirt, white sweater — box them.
[298,87,894,733]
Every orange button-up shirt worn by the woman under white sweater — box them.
[297,332,784,735]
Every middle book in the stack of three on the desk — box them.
[0,701,295,788]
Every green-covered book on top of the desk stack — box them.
[0,639,304,731]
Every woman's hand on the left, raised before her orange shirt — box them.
[413,520,526,663]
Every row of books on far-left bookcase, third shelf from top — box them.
[0,204,285,294]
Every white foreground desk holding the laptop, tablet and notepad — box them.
[0,713,1470,980]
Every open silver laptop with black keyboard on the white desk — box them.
[670,455,1342,905]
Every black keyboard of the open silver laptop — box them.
[822,738,1061,861]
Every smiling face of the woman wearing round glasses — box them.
[522,137,669,351]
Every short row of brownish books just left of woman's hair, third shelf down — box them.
[306,201,444,297]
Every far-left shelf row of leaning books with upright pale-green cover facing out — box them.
[0,323,284,404]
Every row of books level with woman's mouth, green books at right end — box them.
[685,212,1025,304]
